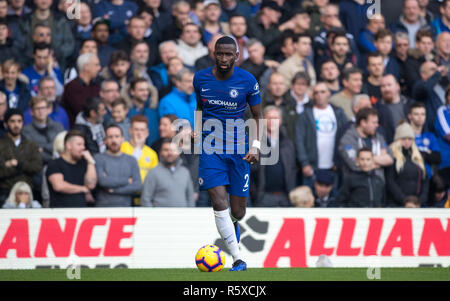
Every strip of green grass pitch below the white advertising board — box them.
[0,268,450,282]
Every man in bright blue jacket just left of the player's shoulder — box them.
[159,68,197,127]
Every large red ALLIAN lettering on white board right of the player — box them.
[263,218,450,267]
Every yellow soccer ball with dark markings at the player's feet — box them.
[195,245,225,272]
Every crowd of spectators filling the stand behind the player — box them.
[0,0,450,208]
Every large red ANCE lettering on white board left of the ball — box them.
[0,217,136,259]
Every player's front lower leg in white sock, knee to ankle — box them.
[208,186,241,262]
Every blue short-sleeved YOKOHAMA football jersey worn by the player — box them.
[194,67,261,151]
